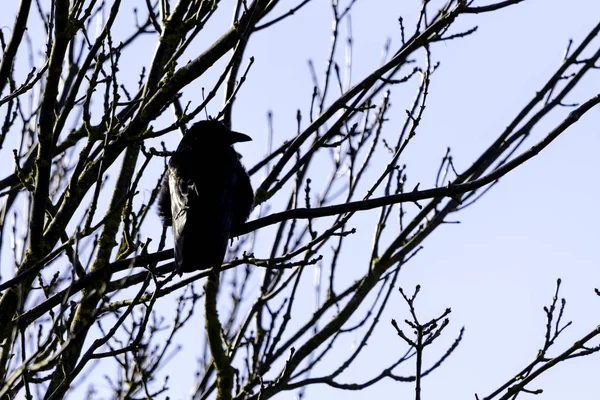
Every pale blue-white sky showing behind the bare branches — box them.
[0,0,600,400]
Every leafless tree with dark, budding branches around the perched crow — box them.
[0,0,600,400]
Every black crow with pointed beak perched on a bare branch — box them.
[158,120,254,274]
